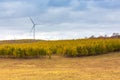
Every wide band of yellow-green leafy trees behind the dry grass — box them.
[0,39,120,58]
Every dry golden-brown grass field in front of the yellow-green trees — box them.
[0,52,120,80]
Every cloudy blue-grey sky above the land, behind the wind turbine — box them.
[0,0,120,40]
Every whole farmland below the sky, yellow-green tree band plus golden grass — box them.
[0,39,120,80]
